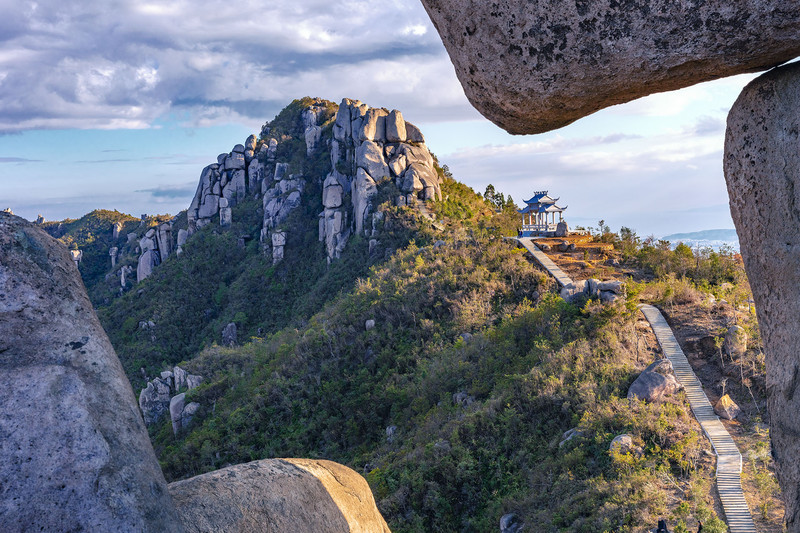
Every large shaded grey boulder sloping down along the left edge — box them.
[0,213,183,532]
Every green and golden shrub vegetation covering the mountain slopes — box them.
[48,98,777,532]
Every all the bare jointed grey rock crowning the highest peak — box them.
[184,98,441,262]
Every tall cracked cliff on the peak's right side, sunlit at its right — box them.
[319,98,442,259]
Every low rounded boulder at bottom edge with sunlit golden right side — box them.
[169,459,389,533]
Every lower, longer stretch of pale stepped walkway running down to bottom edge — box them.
[639,304,756,533]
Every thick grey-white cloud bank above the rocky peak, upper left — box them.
[0,0,450,132]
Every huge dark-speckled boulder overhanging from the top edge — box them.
[422,0,800,133]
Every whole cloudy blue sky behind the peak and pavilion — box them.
[0,0,755,236]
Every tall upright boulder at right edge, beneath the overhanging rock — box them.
[724,61,800,531]
